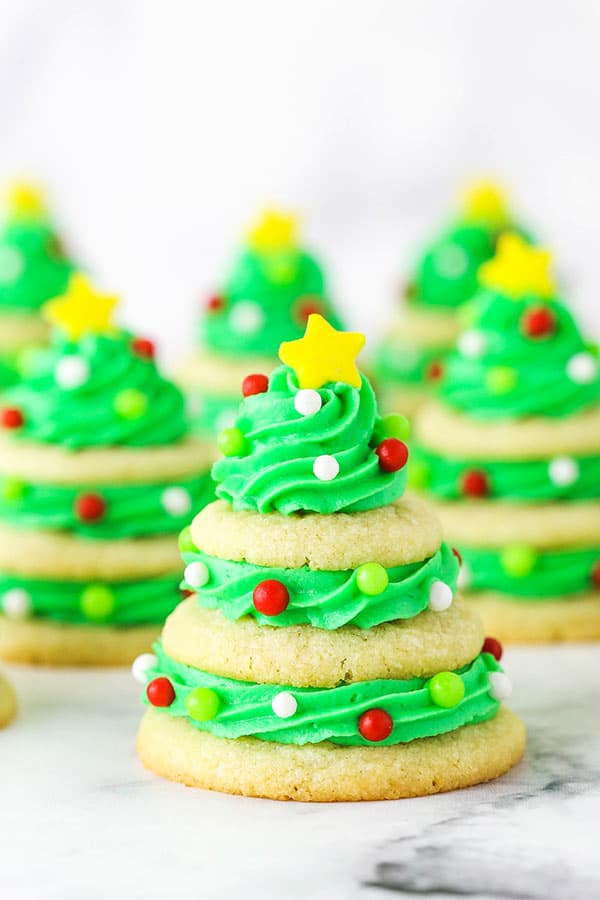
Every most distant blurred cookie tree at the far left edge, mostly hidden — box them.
[0,184,72,387]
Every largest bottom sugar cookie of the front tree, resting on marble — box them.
[137,707,525,801]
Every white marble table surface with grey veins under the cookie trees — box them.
[0,646,600,900]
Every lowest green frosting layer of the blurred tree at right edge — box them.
[460,546,600,601]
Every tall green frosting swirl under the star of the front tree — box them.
[213,366,406,515]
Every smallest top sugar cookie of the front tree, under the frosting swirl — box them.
[191,496,442,571]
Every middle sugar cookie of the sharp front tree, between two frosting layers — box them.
[162,597,484,687]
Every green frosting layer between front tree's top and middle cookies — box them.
[182,544,458,630]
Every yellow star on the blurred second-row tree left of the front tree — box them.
[43,272,118,341]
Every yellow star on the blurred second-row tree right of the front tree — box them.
[478,234,556,300]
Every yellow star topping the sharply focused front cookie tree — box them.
[279,313,365,389]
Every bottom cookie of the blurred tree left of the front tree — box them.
[0,616,160,666]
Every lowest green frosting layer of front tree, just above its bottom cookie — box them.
[146,643,502,747]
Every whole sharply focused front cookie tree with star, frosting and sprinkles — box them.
[134,315,524,800]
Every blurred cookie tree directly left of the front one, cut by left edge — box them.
[0,275,213,664]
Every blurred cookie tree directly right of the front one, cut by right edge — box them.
[411,235,600,641]
